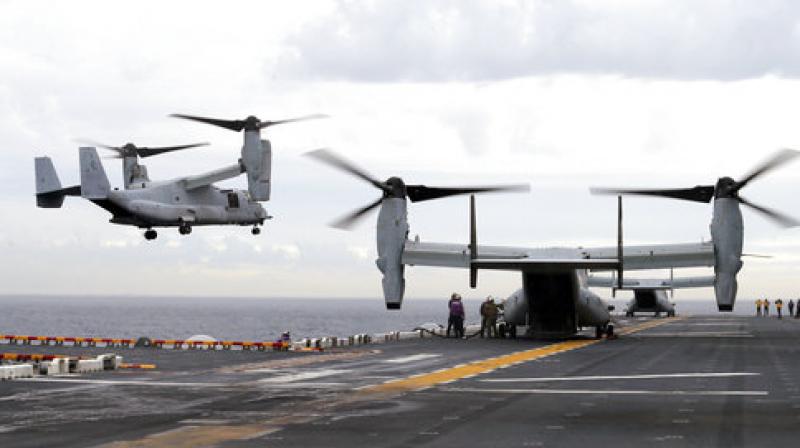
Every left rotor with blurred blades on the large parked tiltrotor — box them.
[306,149,530,229]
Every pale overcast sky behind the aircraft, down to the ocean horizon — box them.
[0,0,800,299]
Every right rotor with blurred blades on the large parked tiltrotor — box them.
[591,149,800,227]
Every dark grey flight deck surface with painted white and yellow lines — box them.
[0,315,800,447]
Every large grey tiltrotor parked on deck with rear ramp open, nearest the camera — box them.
[309,150,795,338]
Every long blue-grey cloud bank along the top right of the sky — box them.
[282,0,800,82]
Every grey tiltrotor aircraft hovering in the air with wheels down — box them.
[35,115,321,240]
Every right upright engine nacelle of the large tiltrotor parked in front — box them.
[711,198,744,311]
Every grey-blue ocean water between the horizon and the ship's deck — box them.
[0,296,753,341]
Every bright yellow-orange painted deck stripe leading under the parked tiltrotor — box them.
[362,318,679,393]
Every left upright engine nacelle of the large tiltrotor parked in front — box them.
[375,197,408,310]
